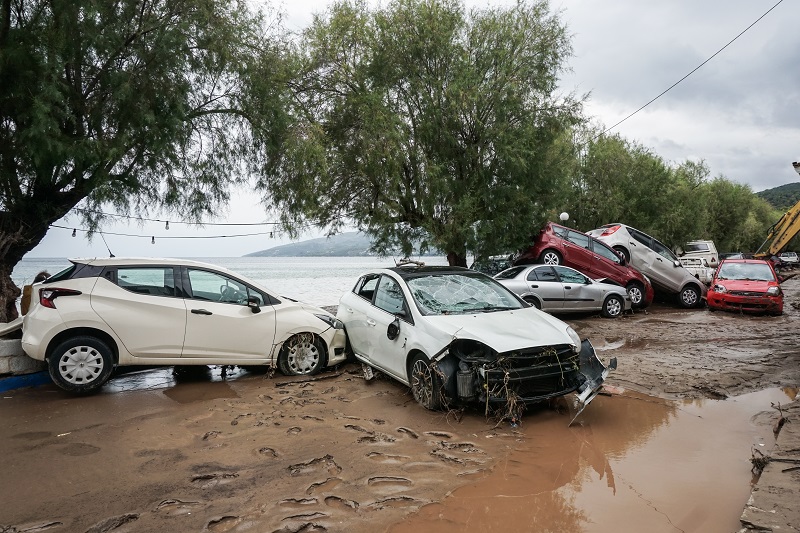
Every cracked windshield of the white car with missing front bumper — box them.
[408,275,522,315]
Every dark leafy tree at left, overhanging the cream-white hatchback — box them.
[0,0,285,322]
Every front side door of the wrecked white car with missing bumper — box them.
[366,274,414,380]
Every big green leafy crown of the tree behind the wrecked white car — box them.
[260,0,578,265]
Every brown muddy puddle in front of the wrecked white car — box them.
[390,389,791,533]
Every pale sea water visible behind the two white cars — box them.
[11,256,447,306]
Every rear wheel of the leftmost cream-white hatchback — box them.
[47,335,114,394]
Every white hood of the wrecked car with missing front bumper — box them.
[425,307,573,353]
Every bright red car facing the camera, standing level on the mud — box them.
[706,259,783,315]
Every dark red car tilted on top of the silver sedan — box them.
[514,222,654,308]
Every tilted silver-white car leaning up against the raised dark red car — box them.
[588,224,706,308]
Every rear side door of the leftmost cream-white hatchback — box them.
[91,266,186,358]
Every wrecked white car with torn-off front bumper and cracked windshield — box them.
[337,266,616,418]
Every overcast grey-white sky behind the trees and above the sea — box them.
[28,0,800,257]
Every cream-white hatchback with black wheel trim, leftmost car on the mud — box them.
[22,258,346,393]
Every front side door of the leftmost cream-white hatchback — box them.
[182,267,280,362]
